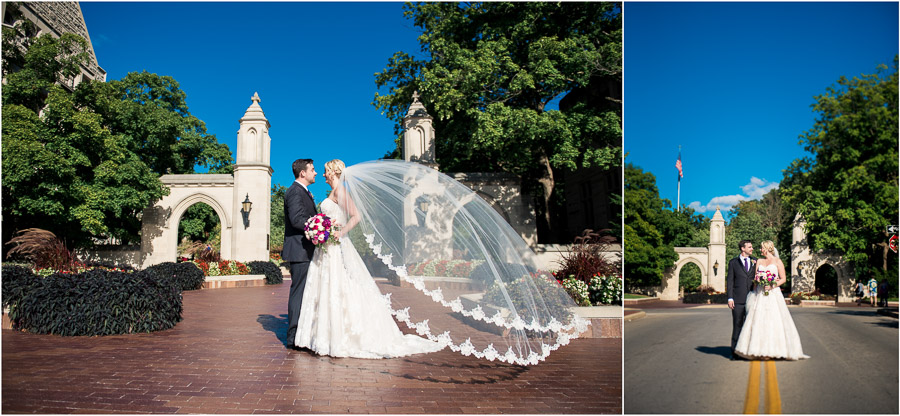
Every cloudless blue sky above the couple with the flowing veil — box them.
[81,2,423,195]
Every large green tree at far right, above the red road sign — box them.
[781,56,898,282]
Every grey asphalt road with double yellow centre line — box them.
[624,305,900,414]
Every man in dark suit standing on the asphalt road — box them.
[725,240,756,360]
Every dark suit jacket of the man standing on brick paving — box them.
[281,181,316,263]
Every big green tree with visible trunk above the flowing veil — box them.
[373,2,622,239]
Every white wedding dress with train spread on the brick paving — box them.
[294,199,444,358]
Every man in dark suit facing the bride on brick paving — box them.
[281,159,316,348]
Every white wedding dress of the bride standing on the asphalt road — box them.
[735,264,809,360]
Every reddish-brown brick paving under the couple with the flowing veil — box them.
[2,280,622,414]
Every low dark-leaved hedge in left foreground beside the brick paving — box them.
[3,267,182,336]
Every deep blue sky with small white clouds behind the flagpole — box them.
[624,2,898,217]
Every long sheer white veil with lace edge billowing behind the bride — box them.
[339,160,588,365]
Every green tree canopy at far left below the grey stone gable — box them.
[2,27,232,250]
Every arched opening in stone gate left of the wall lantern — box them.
[178,202,222,262]
